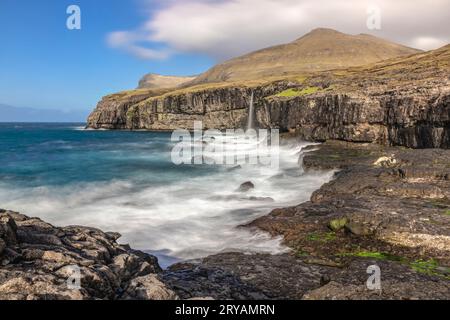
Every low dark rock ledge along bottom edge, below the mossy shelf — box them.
[163,253,450,300]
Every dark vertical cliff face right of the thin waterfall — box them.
[258,83,450,148]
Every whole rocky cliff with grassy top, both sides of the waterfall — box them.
[88,46,450,148]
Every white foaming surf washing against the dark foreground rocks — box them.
[0,136,333,264]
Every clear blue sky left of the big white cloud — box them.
[0,0,213,115]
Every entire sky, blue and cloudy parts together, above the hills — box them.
[0,0,450,120]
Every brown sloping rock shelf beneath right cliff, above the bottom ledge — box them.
[251,142,450,266]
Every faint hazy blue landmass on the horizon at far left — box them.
[0,104,89,122]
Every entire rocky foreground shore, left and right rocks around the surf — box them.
[0,141,450,300]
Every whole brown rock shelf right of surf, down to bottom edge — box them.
[163,141,450,299]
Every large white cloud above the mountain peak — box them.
[108,0,450,60]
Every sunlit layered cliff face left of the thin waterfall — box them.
[88,83,285,130]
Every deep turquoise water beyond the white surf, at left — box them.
[0,123,218,187]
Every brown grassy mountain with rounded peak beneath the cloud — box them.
[186,28,420,85]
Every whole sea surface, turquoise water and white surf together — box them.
[0,123,331,265]
